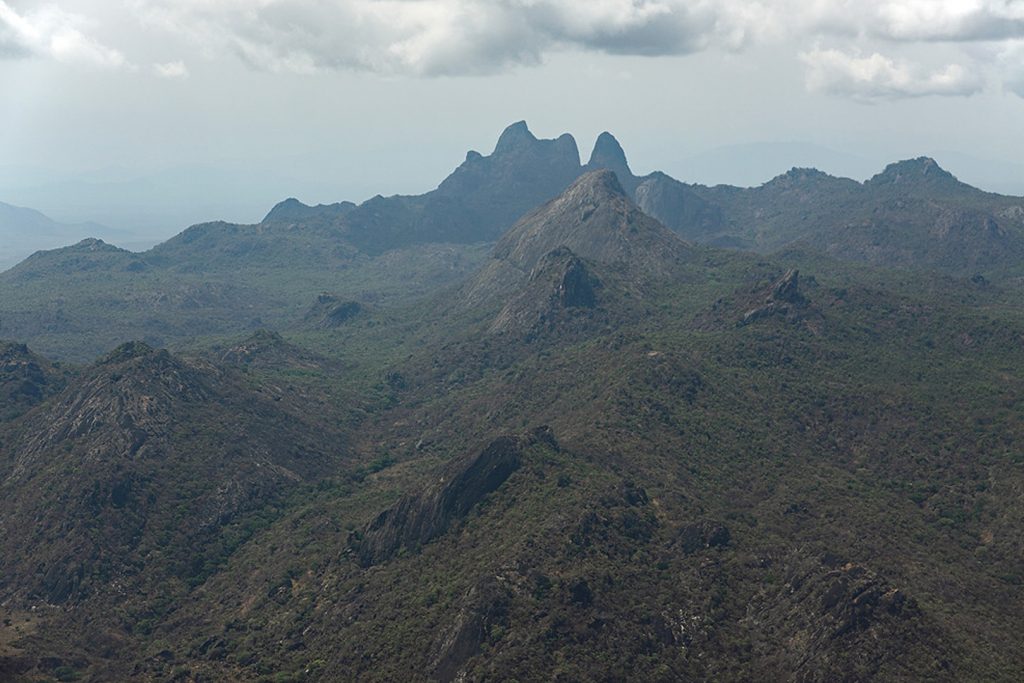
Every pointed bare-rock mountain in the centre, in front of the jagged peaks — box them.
[462,170,693,334]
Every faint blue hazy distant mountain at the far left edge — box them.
[0,202,125,270]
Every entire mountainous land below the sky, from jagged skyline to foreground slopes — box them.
[0,124,1024,683]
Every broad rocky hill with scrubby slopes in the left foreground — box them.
[0,343,345,604]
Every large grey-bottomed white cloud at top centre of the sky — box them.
[128,0,768,76]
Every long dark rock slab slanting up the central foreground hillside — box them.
[355,430,554,566]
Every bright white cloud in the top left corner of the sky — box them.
[0,0,125,68]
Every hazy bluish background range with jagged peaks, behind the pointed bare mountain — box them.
[0,122,1024,360]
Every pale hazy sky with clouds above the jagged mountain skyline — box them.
[0,0,1024,237]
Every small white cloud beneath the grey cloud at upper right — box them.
[800,49,984,99]
